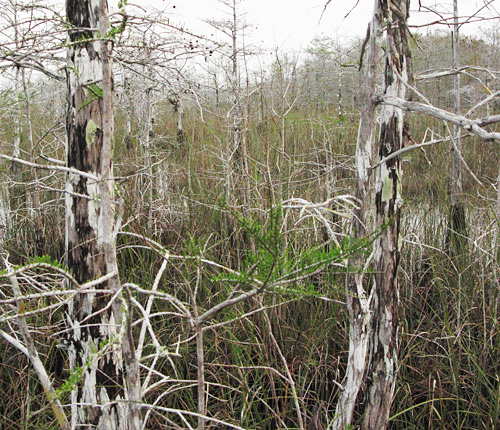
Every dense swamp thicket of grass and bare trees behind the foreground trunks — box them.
[0,2,500,430]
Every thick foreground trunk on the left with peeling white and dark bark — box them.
[66,0,141,430]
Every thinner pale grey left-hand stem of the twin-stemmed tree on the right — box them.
[330,0,382,430]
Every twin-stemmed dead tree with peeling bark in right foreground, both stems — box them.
[331,0,409,430]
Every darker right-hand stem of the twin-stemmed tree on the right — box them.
[362,0,409,430]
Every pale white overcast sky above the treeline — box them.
[135,0,500,51]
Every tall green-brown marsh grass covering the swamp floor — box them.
[0,66,500,430]
